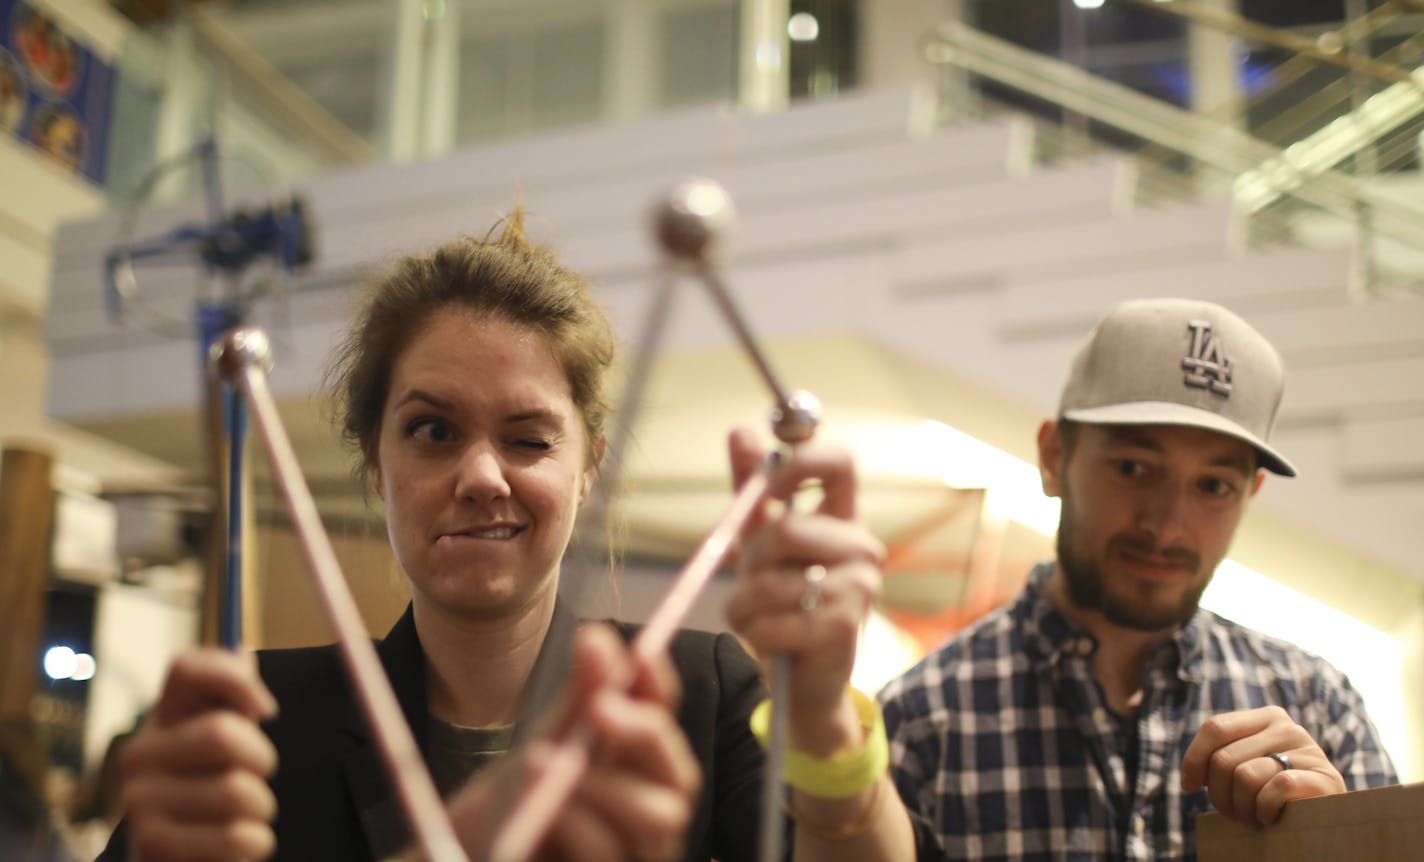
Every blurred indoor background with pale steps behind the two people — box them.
[0,0,1424,856]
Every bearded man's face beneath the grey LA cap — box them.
[1040,423,1262,631]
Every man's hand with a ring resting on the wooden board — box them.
[1182,707,1346,825]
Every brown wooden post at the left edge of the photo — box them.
[0,447,54,718]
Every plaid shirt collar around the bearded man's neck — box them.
[1010,560,1206,682]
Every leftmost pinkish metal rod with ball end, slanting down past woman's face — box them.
[215,329,467,862]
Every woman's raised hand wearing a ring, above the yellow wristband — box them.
[726,429,884,757]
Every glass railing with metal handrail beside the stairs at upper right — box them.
[923,0,1424,292]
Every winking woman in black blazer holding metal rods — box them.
[108,214,910,862]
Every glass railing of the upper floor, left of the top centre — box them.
[100,0,860,201]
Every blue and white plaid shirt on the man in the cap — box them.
[880,563,1398,862]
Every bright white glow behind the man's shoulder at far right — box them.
[1202,560,1413,768]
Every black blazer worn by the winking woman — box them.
[100,606,763,862]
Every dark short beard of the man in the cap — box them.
[1057,489,1210,631]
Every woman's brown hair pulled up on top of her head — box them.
[326,207,614,480]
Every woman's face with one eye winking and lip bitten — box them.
[376,309,594,617]
